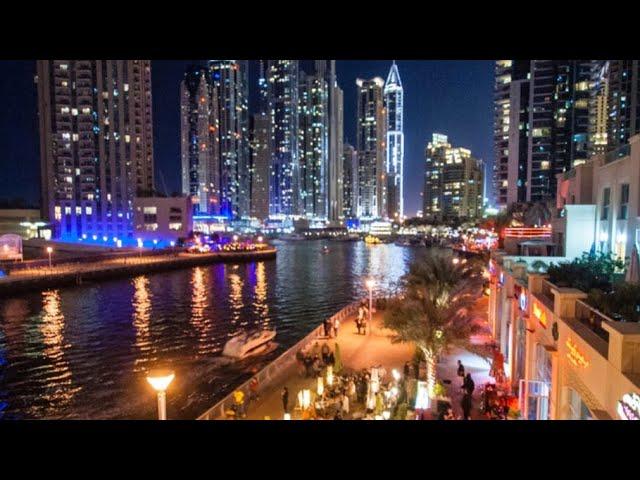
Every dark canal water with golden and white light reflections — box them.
[0,240,417,419]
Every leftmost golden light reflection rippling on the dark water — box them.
[40,290,81,408]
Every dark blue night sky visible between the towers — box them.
[0,60,493,215]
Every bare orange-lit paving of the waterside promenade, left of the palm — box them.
[247,313,415,420]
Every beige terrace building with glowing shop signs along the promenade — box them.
[489,255,640,420]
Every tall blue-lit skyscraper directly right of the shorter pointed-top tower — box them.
[209,60,251,218]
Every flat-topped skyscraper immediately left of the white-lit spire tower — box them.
[356,77,386,219]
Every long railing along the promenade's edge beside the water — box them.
[198,300,362,420]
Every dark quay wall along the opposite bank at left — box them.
[0,248,276,296]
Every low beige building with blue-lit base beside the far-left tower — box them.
[133,197,193,246]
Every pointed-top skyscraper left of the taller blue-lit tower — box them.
[180,67,220,214]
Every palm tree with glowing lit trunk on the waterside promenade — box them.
[383,249,486,397]
